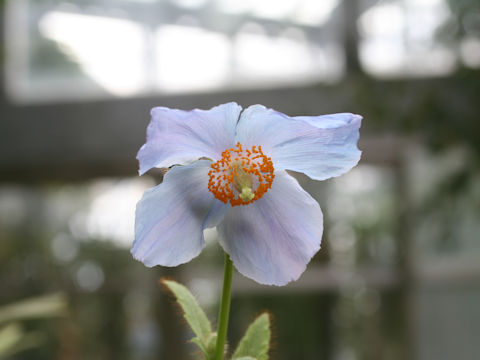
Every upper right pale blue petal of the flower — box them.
[236,105,362,180]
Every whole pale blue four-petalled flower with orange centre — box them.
[132,103,362,285]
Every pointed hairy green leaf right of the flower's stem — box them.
[232,313,270,360]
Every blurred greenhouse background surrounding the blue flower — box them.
[0,0,480,360]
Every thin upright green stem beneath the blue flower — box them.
[214,254,233,360]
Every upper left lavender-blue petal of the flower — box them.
[137,102,242,175]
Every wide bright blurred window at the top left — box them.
[2,0,343,101]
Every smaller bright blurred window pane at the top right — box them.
[358,0,457,76]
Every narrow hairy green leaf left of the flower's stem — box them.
[162,280,212,344]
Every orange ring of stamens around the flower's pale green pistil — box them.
[208,143,275,206]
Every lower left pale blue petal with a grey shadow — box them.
[131,160,227,267]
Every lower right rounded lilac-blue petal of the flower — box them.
[218,171,323,285]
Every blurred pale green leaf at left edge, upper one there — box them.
[0,294,67,324]
